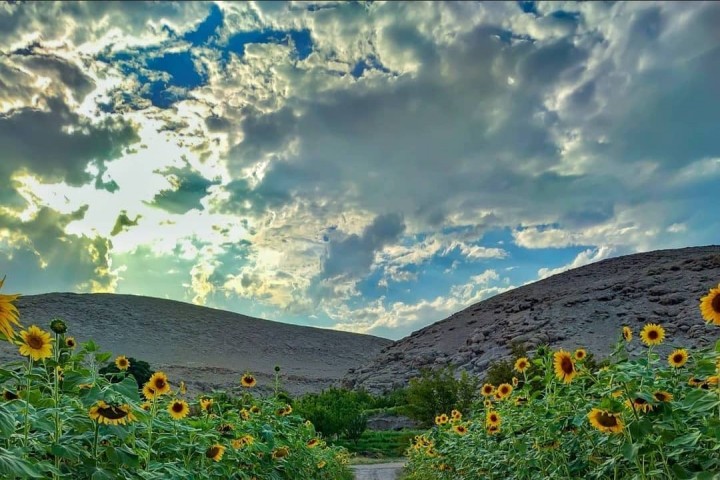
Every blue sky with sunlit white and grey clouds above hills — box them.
[0,1,720,339]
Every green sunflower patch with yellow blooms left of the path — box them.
[0,280,352,480]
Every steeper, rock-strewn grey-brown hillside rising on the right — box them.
[343,246,720,392]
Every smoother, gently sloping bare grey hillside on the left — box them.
[0,293,392,394]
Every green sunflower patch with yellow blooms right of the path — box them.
[404,285,720,480]
